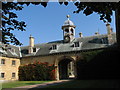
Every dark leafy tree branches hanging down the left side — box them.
[2,2,47,45]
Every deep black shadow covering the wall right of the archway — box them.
[77,48,120,79]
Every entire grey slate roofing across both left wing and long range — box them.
[0,33,116,58]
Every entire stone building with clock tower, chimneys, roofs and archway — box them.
[0,15,116,80]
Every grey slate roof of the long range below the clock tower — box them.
[21,33,116,57]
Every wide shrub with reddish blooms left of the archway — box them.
[18,62,55,81]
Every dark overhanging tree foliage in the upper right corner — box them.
[74,2,120,22]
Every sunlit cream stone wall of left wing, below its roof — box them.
[0,57,20,80]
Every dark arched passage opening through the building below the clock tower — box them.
[58,59,75,79]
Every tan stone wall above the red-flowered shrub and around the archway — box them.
[20,53,80,80]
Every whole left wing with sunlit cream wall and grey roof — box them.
[0,43,20,81]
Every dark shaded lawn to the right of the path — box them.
[46,80,119,88]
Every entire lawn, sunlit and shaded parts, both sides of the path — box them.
[2,80,120,90]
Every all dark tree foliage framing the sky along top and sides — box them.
[2,0,120,46]
